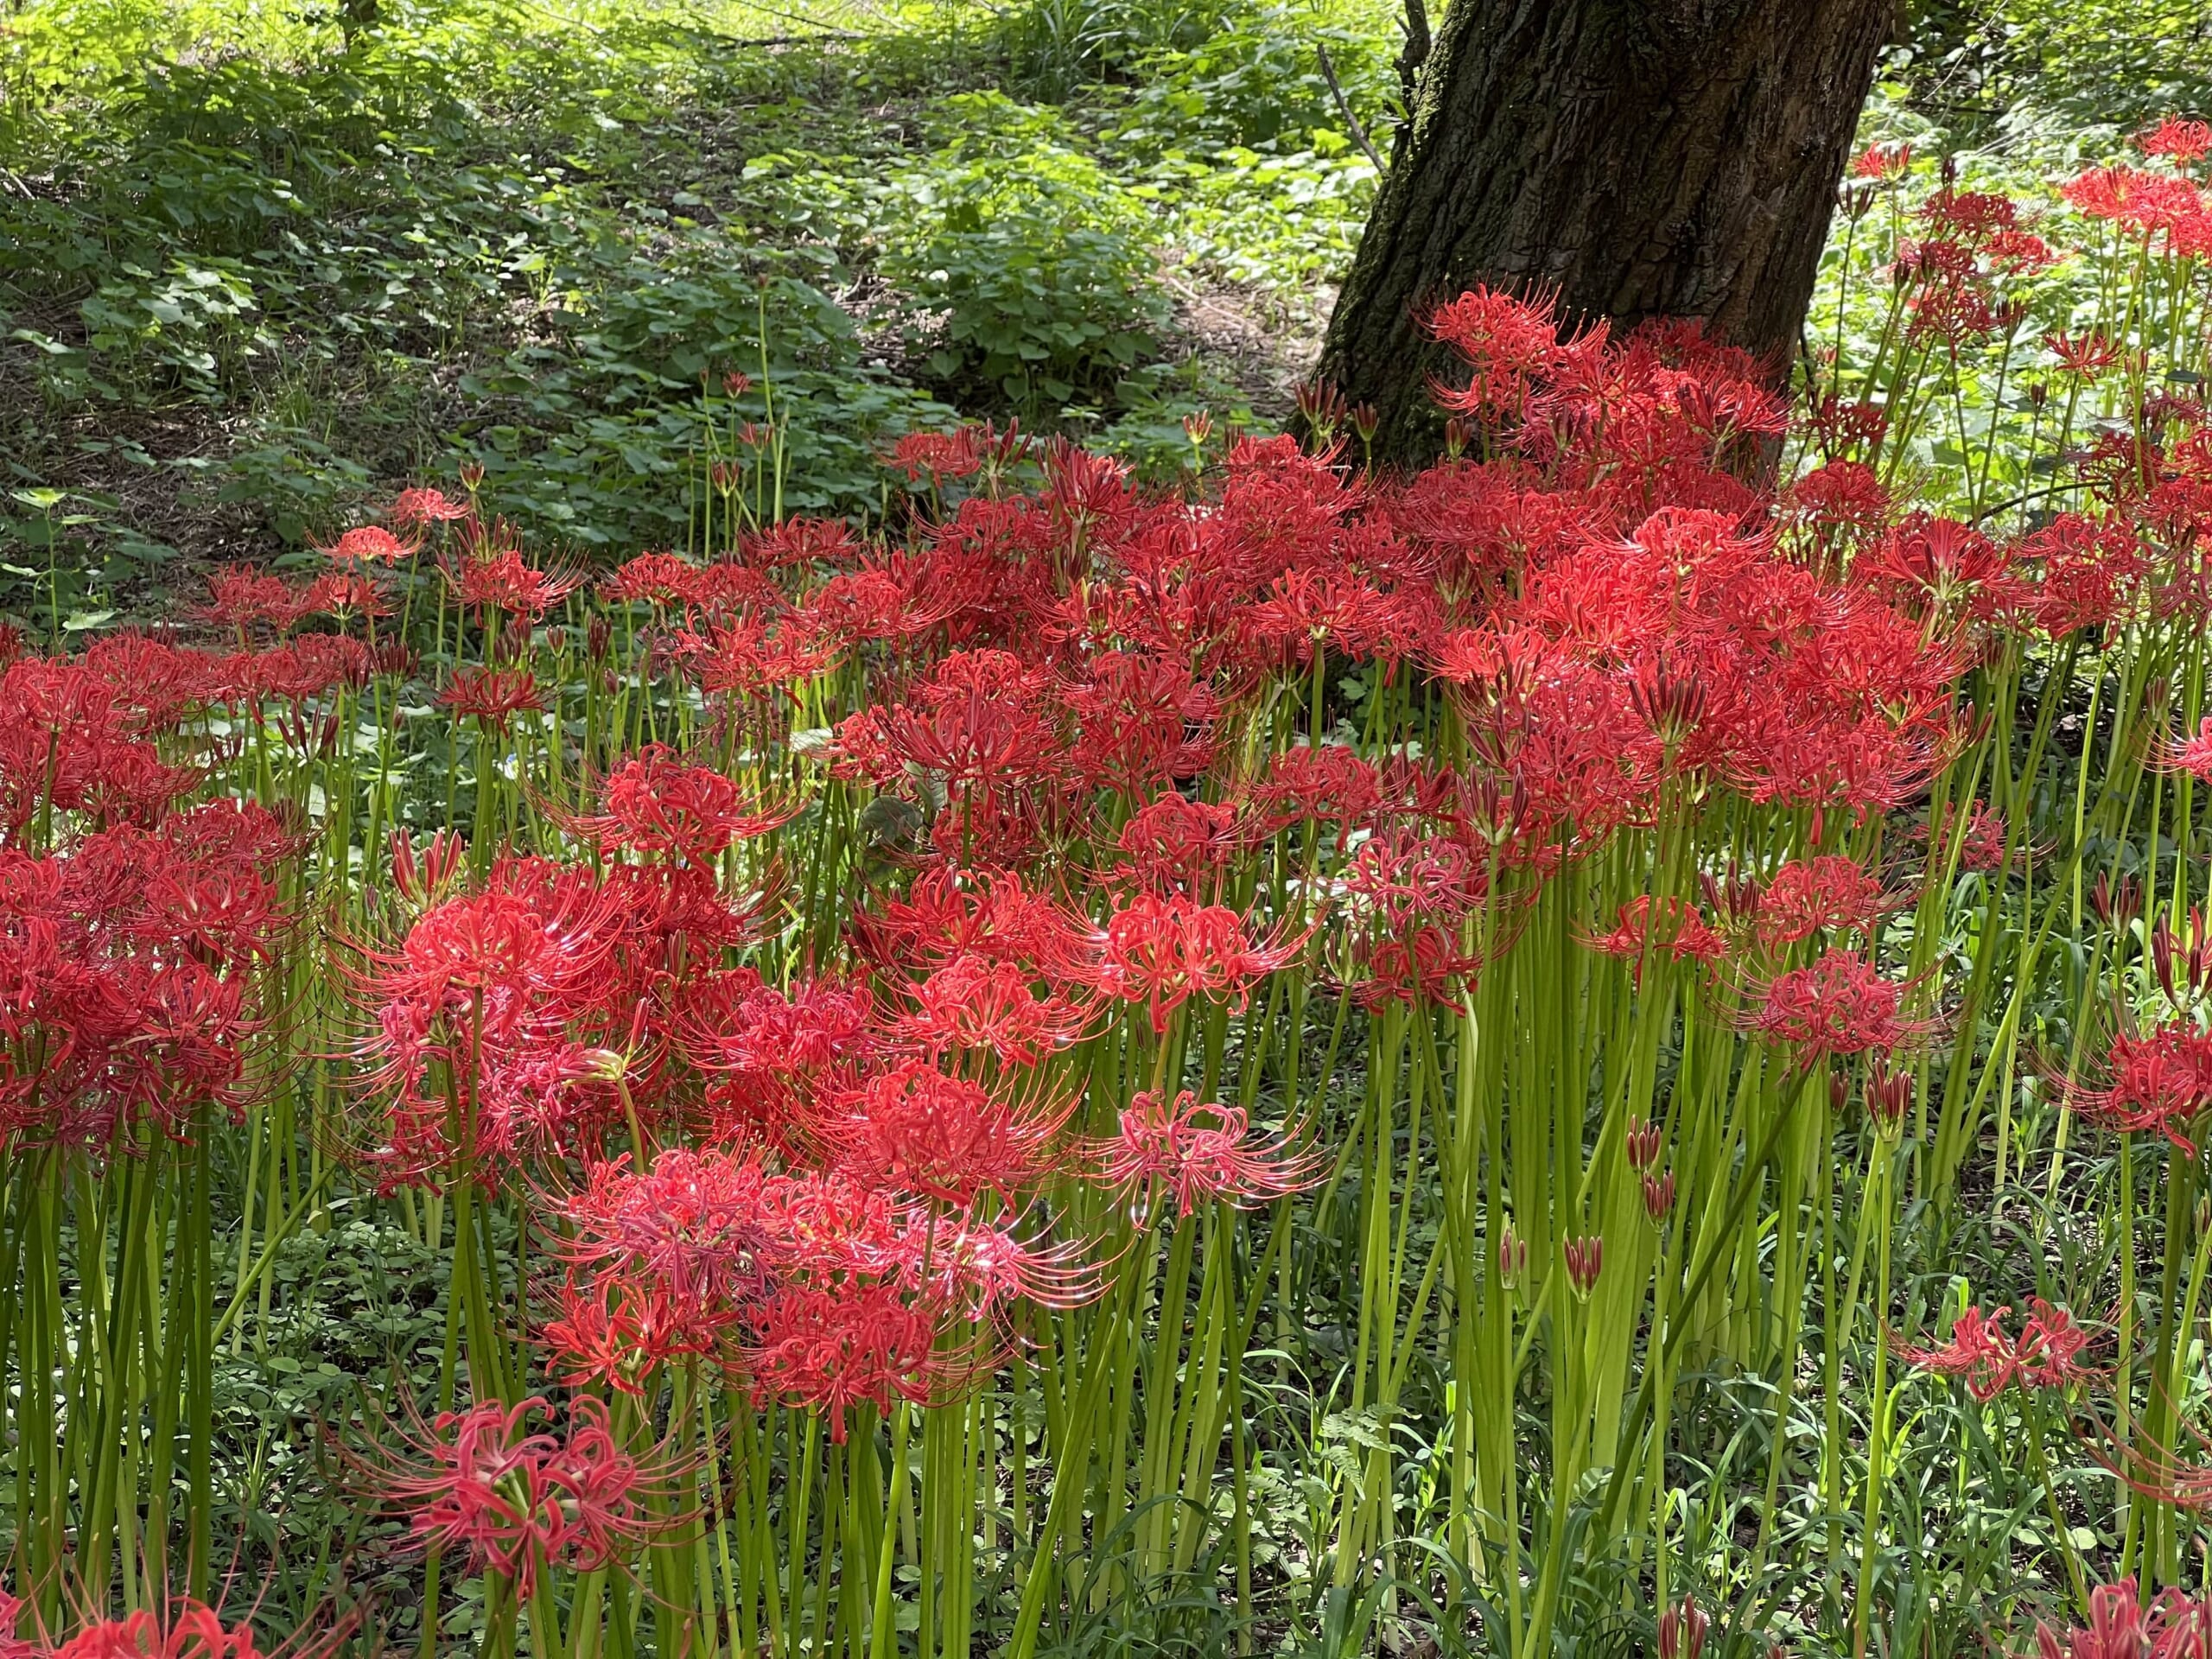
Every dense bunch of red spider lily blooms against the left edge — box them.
[0,651,301,1146]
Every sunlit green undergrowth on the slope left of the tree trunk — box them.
[0,0,1389,631]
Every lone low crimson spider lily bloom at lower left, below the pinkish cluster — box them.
[383,1394,648,1599]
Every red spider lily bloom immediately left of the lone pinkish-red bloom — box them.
[814,1062,1075,1210]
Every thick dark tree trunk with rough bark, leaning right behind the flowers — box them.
[1320,0,1891,465]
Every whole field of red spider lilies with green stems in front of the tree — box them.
[13,122,2212,1659]
